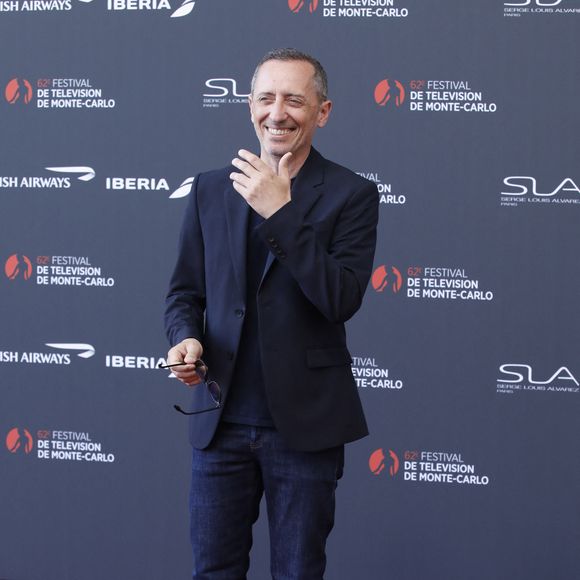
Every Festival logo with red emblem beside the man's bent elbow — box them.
[371,264,494,302]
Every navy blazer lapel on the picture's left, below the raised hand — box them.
[224,186,250,303]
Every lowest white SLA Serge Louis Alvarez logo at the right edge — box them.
[496,363,580,395]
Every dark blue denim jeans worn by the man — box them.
[190,423,344,580]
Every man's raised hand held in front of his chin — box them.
[230,149,292,219]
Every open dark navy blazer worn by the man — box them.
[165,149,379,451]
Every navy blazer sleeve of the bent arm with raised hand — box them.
[259,181,379,322]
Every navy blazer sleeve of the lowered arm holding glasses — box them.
[165,175,206,346]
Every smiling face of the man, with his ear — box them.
[249,60,332,161]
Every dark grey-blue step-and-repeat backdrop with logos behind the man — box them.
[0,0,580,580]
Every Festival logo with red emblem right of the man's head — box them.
[373,78,497,113]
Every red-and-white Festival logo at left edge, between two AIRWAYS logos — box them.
[4,254,115,288]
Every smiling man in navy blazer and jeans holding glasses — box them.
[166,49,378,580]
